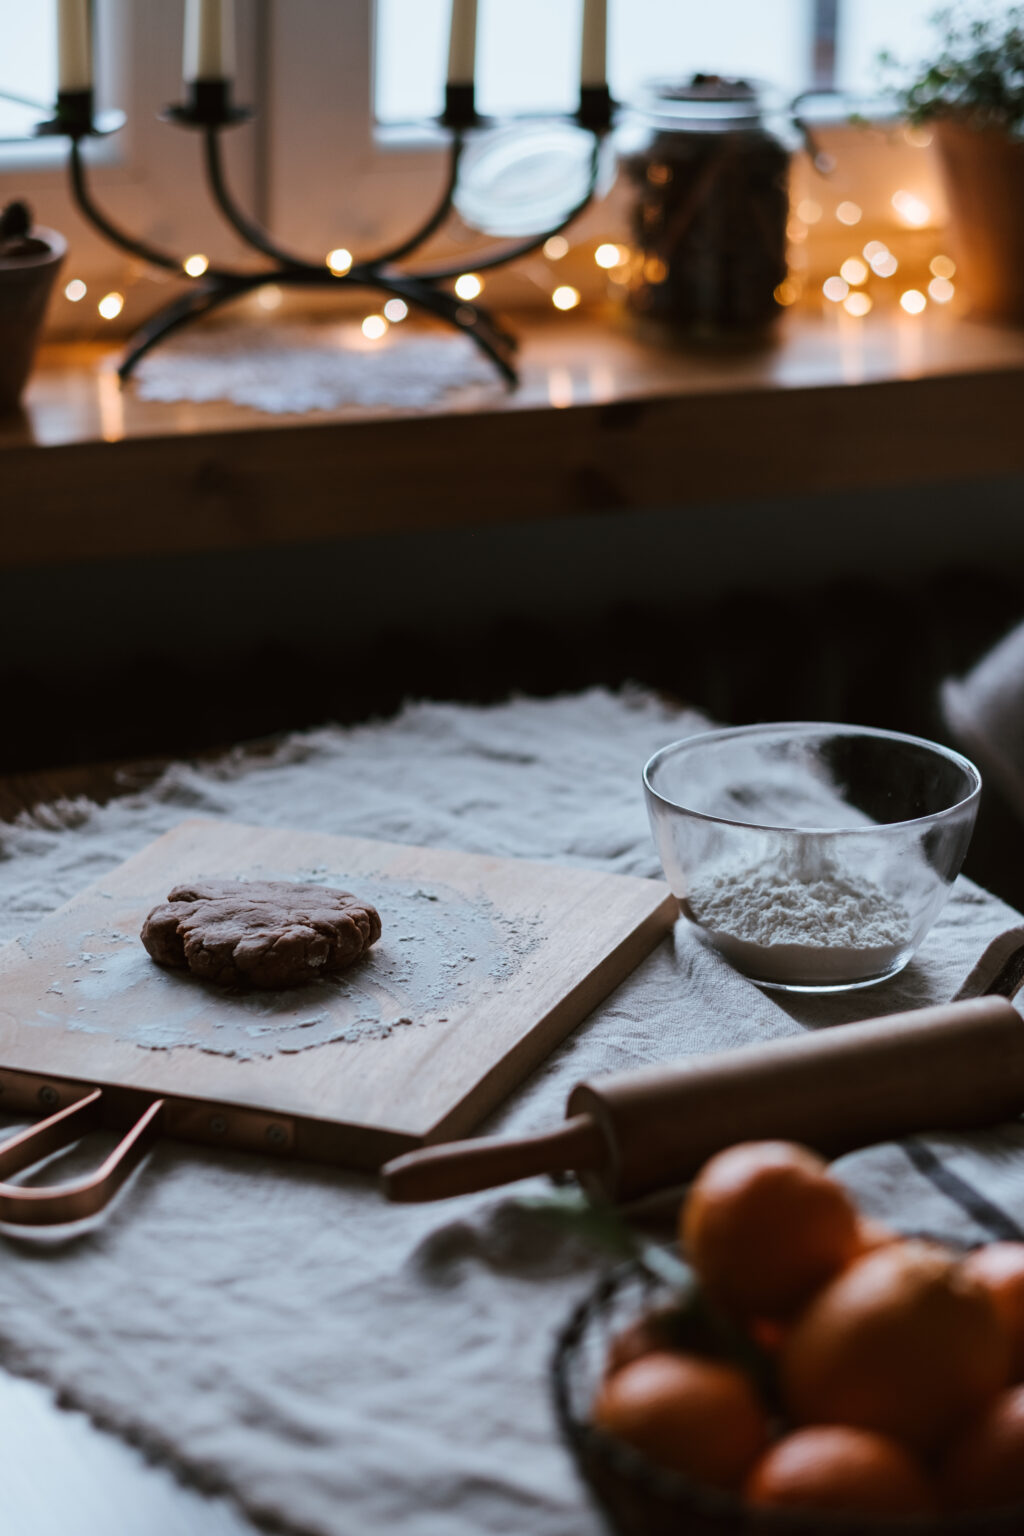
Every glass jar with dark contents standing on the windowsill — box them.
[619,75,797,339]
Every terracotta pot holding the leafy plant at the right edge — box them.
[935,117,1024,324]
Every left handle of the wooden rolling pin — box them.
[381,1115,608,1204]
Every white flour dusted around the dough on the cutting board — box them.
[26,868,540,1061]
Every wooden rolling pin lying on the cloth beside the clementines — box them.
[382,997,1024,1201]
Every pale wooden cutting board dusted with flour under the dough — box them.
[0,819,679,1167]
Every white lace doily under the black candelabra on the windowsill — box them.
[135,323,504,415]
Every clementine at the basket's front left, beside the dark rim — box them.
[593,1353,768,1488]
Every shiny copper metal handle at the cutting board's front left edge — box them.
[0,1087,164,1227]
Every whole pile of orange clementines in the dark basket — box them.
[593,1141,1024,1530]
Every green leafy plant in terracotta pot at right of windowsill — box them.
[889,5,1024,323]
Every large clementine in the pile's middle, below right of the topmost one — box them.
[780,1241,1009,1450]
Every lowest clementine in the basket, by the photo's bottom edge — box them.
[745,1424,935,1514]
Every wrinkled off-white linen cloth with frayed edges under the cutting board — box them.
[0,691,1024,1536]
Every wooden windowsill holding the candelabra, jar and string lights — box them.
[0,312,1024,567]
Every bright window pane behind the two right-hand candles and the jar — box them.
[376,0,812,123]
